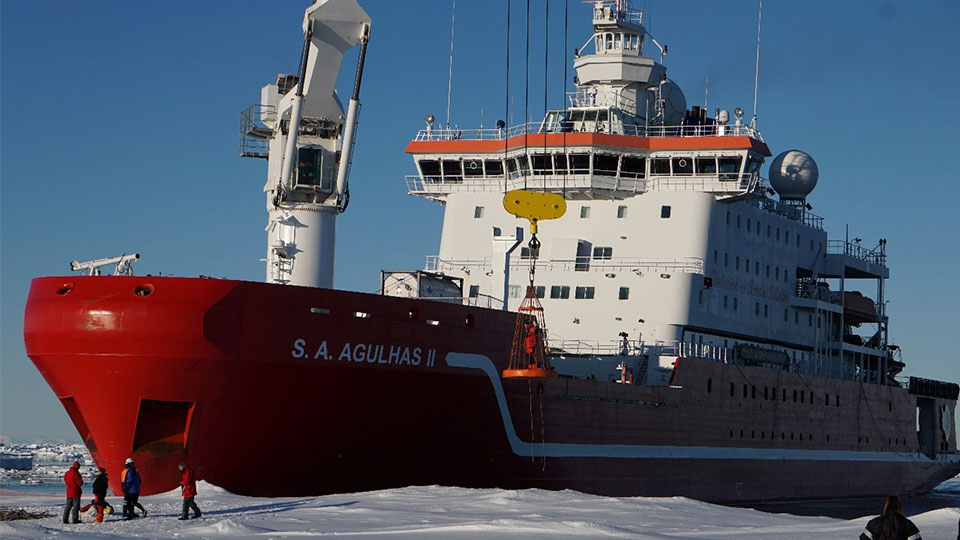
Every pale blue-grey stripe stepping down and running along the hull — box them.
[445,352,960,464]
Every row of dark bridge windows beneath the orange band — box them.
[417,152,763,182]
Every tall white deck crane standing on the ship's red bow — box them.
[240,0,370,288]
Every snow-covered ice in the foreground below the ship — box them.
[0,482,960,540]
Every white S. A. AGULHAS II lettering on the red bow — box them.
[290,338,437,367]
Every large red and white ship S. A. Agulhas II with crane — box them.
[24,0,960,503]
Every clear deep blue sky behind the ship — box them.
[0,0,960,440]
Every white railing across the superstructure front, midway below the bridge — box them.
[425,255,704,274]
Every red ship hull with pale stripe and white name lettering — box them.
[24,277,960,502]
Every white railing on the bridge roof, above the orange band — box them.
[413,120,763,141]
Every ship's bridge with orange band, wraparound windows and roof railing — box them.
[406,112,770,200]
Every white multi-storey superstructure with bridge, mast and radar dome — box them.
[406,0,899,382]
